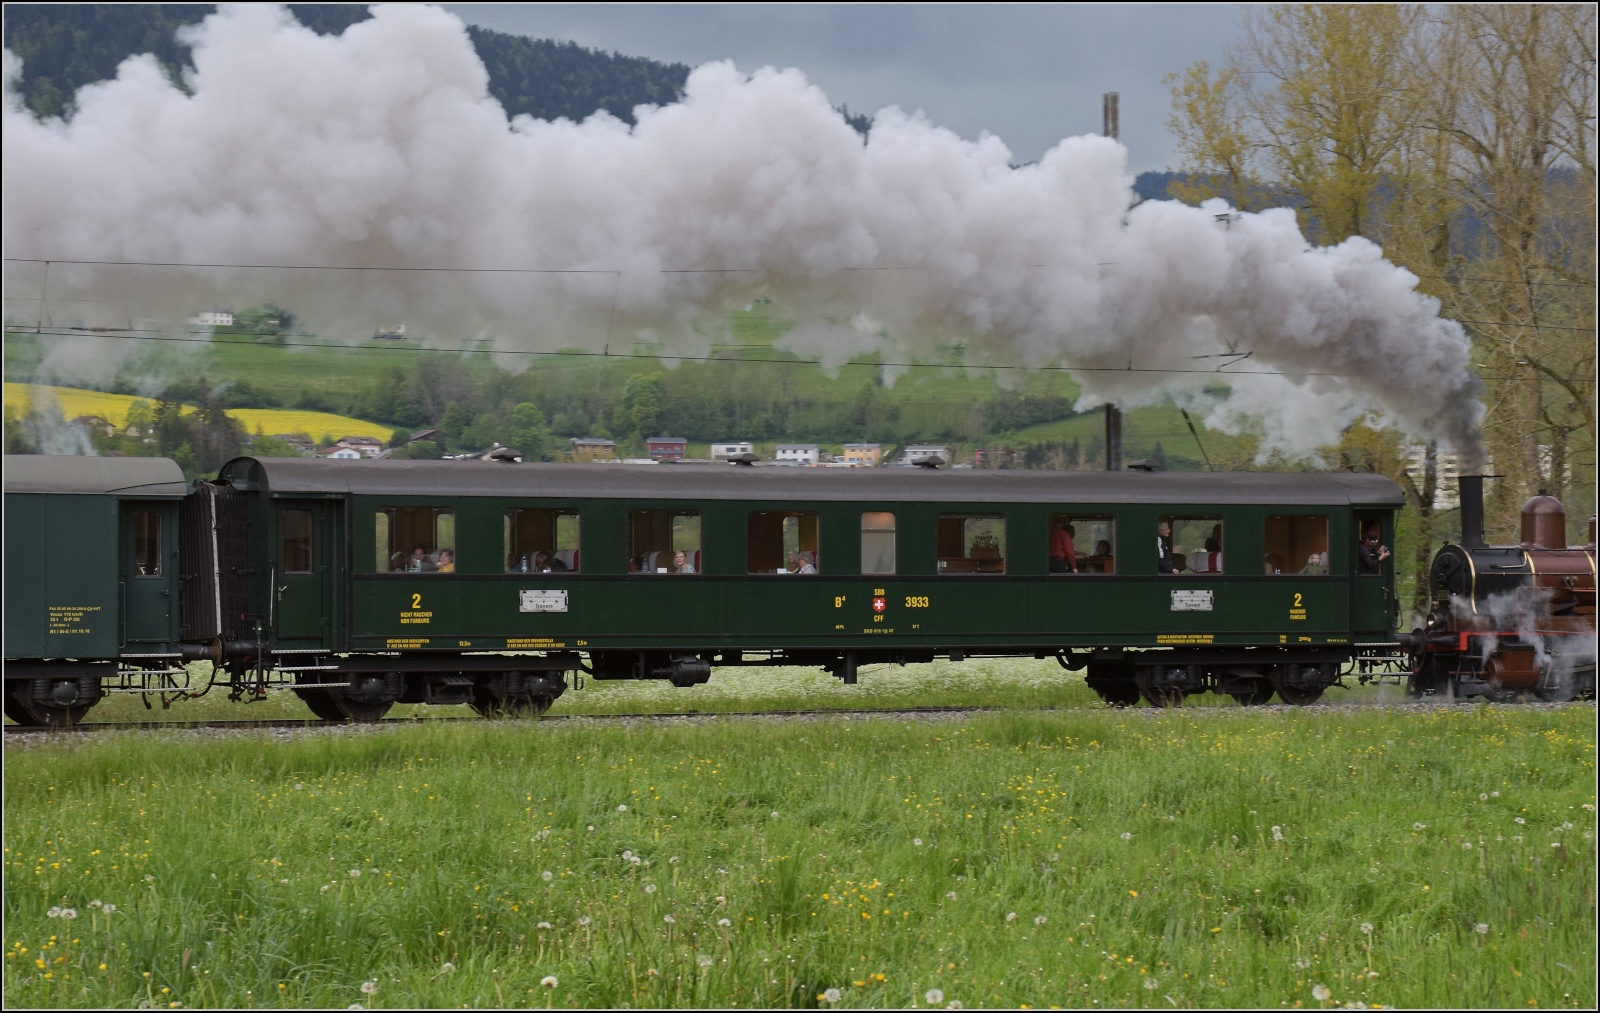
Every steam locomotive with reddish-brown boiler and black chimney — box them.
[1397,475,1595,701]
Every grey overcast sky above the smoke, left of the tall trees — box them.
[446,3,1240,173]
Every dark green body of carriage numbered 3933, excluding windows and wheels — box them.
[212,458,1402,661]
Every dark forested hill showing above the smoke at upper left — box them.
[5,3,690,123]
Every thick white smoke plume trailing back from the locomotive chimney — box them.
[3,5,1482,454]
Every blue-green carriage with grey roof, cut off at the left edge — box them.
[5,454,186,723]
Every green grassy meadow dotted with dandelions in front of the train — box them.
[3,706,1597,1008]
